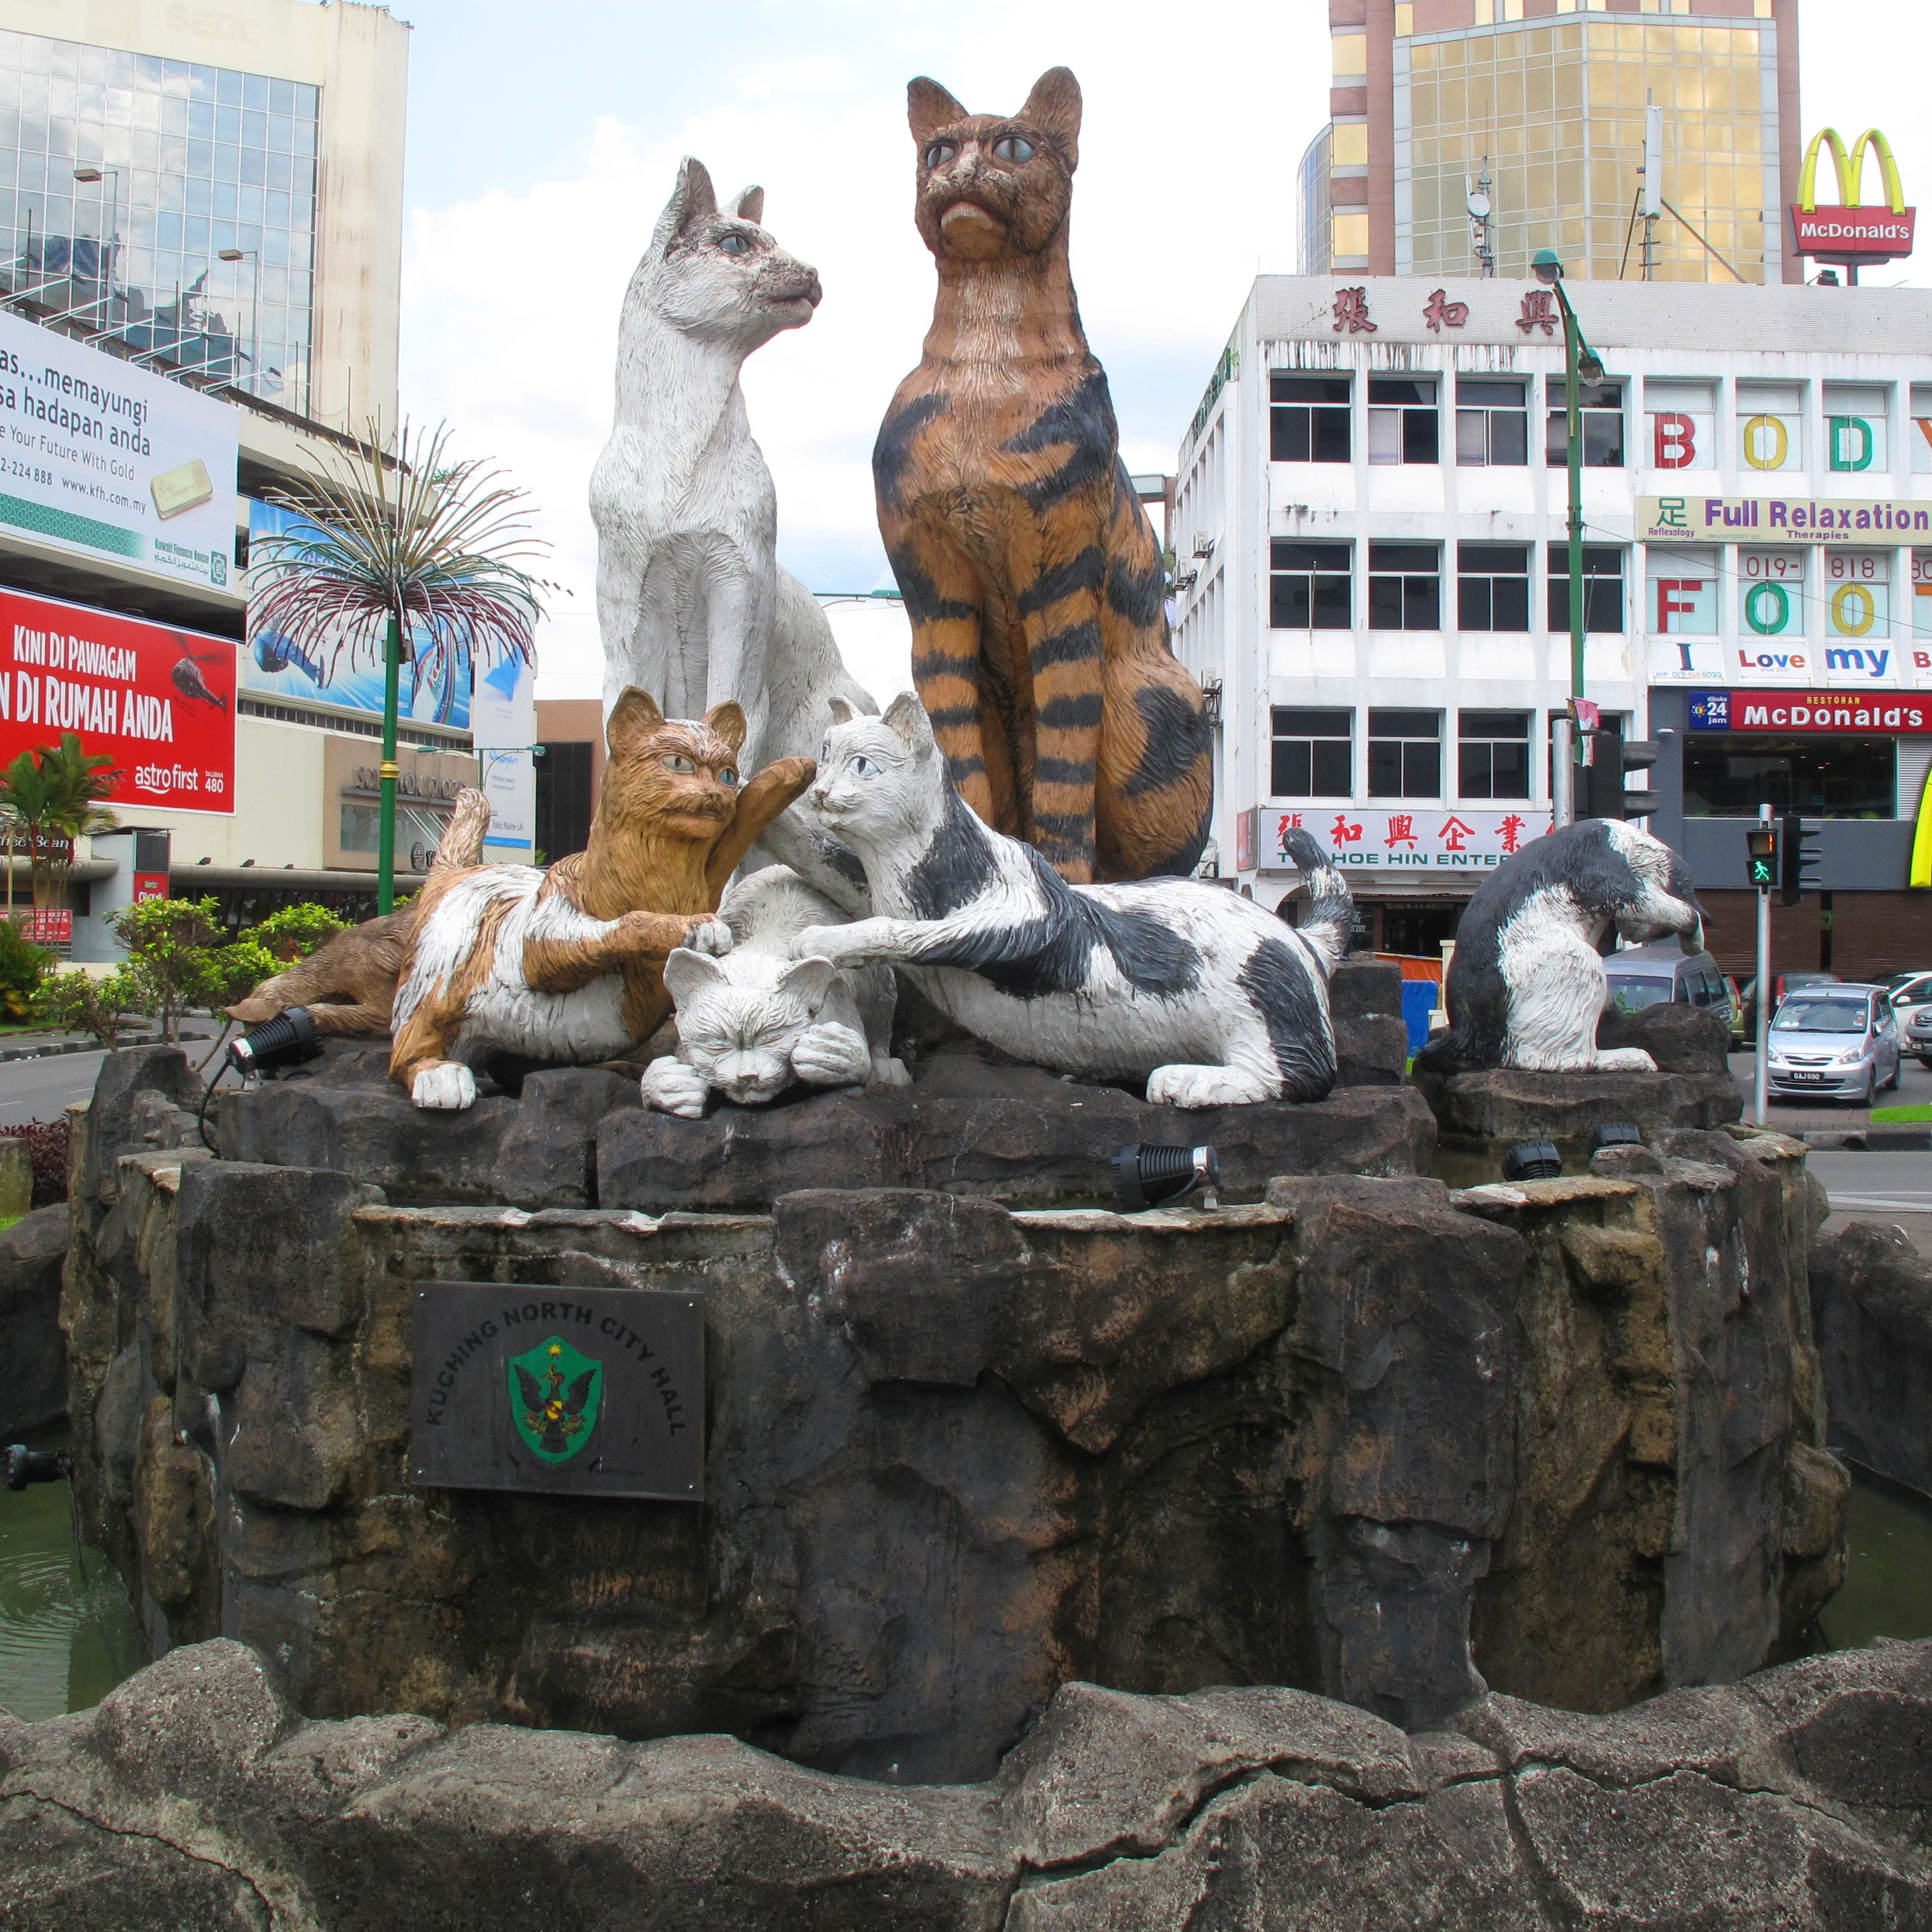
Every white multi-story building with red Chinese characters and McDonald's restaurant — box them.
[1173,276,1932,972]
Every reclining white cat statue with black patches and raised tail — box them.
[792,694,1354,1107]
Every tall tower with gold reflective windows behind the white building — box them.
[1299,0,1804,282]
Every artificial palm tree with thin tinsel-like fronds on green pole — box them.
[247,423,550,912]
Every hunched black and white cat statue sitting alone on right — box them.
[1416,819,1704,1074]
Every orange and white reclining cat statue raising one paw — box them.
[388,686,815,1109]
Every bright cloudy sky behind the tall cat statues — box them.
[390,0,1932,697]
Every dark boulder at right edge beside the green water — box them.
[1810,1221,1932,1495]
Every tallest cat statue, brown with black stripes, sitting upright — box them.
[871,68,1214,885]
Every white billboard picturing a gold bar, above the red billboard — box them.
[0,315,236,588]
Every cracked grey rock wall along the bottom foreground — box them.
[0,1640,1932,1932]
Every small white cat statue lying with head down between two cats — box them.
[643,865,906,1121]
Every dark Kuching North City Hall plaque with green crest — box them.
[409,1281,705,1503]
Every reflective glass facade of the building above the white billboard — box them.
[0,33,321,415]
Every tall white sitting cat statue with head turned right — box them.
[591,158,877,912]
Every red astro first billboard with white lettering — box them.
[0,590,236,811]
